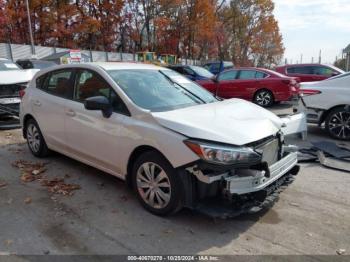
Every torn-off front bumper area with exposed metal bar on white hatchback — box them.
[182,148,299,218]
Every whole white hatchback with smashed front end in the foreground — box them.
[20,63,301,215]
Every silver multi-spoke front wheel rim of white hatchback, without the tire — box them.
[136,162,171,209]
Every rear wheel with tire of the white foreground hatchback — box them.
[25,119,49,158]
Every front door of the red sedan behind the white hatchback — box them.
[217,70,240,98]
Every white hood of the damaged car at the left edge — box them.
[0,69,39,85]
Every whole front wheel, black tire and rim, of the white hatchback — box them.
[132,151,183,216]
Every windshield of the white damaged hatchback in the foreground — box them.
[107,69,218,112]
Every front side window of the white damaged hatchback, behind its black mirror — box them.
[74,70,130,115]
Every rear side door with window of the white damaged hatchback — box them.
[30,69,74,149]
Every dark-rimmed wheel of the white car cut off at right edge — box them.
[325,108,350,140]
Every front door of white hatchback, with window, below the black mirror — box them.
[65,69,130,174]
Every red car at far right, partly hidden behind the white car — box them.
[276,64,344,82]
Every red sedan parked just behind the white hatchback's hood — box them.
[197,67,299,107]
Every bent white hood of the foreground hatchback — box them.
[152,99,282,145]
